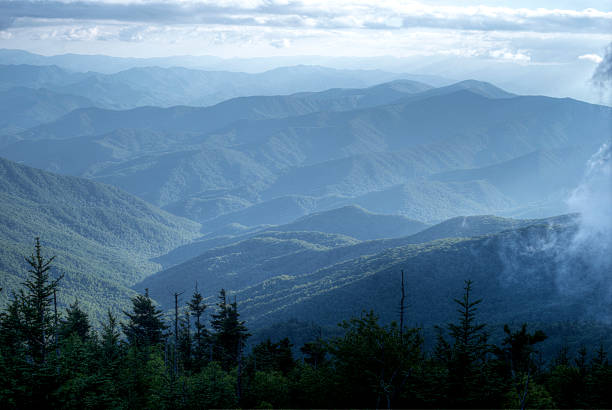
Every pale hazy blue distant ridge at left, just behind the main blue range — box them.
[0,64,431,109]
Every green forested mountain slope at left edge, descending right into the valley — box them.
[0,159,199,317]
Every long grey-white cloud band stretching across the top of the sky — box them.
[0,0,612,33]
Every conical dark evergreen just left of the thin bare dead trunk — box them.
[121,290,168,347]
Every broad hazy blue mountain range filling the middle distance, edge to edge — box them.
[0,81,611,226]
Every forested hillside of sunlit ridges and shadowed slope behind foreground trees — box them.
[137,216,588,326]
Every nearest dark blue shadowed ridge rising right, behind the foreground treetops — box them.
[236,221,596,327]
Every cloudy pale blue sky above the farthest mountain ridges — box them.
[0,0,612,63]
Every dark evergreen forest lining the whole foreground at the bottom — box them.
[0,239,612,409]
